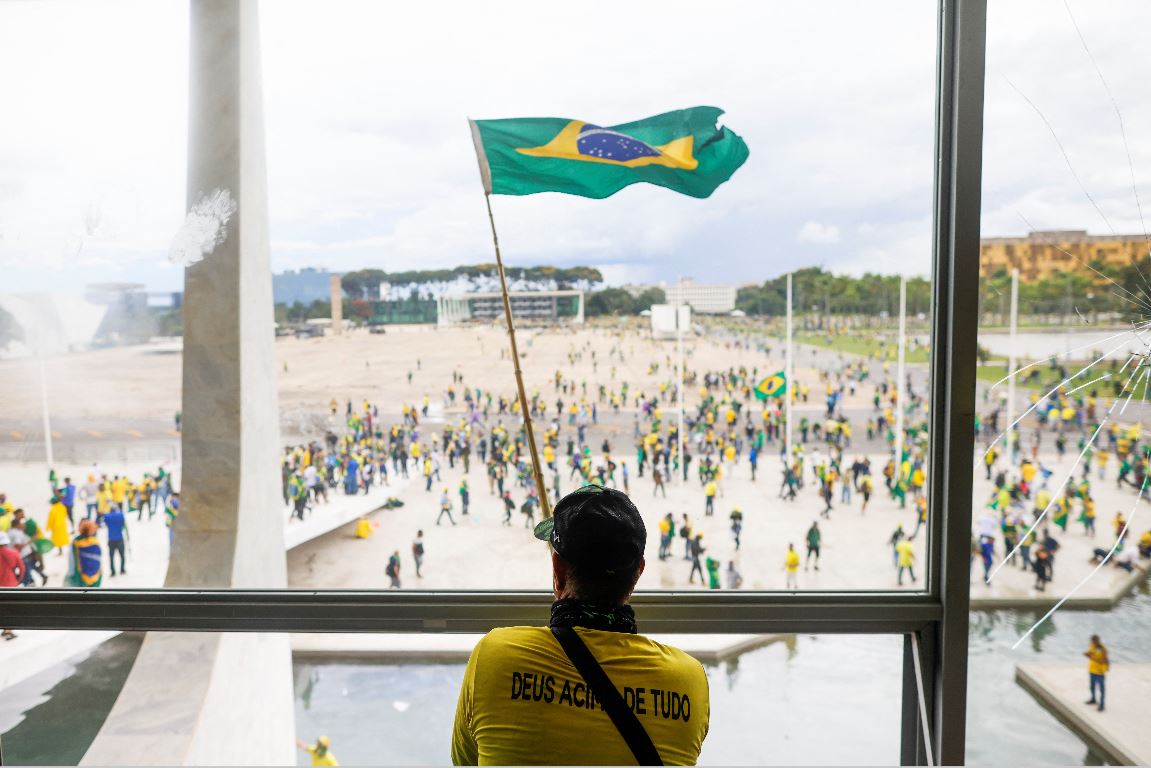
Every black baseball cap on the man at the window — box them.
[534,485,647,573]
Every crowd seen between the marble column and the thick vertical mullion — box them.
[271,327,953,588]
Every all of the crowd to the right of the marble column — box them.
[317,324,1151,590]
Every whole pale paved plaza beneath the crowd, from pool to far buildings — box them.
[0,320,1151,704]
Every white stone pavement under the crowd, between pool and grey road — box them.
[0,437,1151,689]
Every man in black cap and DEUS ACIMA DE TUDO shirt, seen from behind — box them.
[451,486,710,766]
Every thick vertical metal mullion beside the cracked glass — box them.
[920,0,986,765]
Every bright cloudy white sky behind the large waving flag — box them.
[0,0,1151,292]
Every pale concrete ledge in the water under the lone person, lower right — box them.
[1015,662,1151,766]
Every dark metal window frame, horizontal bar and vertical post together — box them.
[0,0,986,765]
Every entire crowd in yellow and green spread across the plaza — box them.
[8,332,1151,607]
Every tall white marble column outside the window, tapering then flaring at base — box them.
[83,0,295,765]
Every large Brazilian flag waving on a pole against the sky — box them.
[470,107,747,198]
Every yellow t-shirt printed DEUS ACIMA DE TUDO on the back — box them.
[451,626,710,766]
